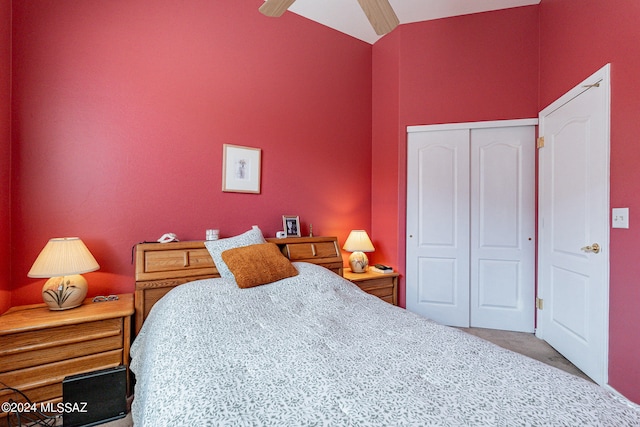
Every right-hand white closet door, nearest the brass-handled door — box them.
[470,126,535,332]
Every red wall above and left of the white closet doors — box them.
[372,6,538,305]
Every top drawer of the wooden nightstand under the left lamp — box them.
[0,318,123,372]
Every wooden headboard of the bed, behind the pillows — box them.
[135,237,342,335]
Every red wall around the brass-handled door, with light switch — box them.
[539,0,640,403]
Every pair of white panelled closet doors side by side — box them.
[406,121,535,332]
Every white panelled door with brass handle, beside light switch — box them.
[537,65,609,384]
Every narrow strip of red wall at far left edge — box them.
[0,0,11,313]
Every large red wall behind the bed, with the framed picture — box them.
[8,0,372,305]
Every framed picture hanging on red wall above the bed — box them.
[222,144,262,194]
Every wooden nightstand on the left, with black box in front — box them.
[0,294,133,418]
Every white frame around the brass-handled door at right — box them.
[536,64,611,386]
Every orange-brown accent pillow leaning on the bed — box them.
[222,243,298,288]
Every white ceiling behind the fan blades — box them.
[280,0,540,44]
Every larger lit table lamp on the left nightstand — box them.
[27,237,100,310]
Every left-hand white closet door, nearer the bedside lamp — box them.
[406,130,469,326]
